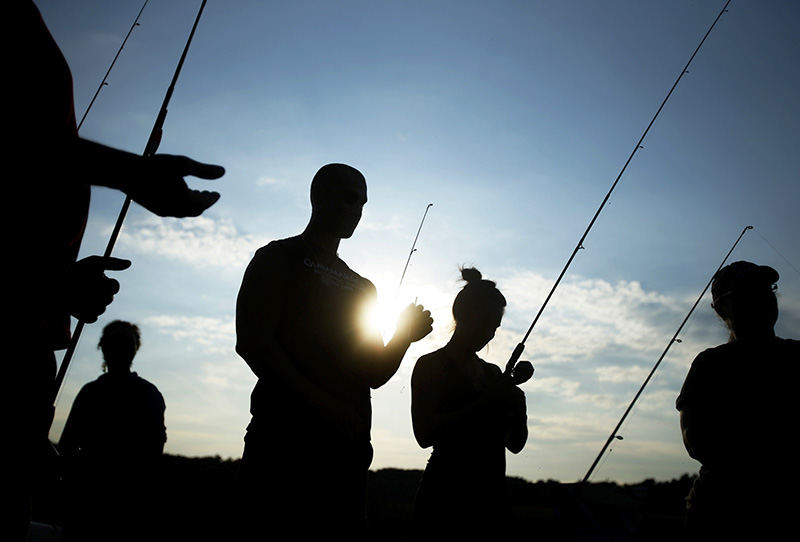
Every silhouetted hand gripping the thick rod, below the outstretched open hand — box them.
[64,256,131,324]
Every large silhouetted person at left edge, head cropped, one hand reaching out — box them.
[7,0,224,540]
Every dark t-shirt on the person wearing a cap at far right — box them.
[676,337,800,506]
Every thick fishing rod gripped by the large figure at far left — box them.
[53,0,207,400]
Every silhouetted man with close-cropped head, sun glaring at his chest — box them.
[236,164,432,539]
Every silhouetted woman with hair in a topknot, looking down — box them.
[411,268,528,540]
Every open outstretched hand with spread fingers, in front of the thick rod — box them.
[125,154,225,218]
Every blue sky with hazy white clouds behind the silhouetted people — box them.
[36,0,800,481]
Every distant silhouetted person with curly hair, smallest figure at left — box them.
[59,320,167,541]
